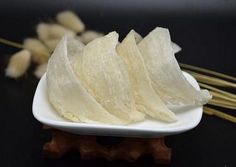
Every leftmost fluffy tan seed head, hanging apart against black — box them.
[6,49,31,78]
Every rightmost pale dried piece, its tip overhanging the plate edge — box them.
[138,27,211,108]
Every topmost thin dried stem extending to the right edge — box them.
[179,63,236,82]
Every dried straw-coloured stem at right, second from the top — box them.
[184,70,236,88]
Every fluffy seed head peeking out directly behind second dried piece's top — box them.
[80,30,104,44]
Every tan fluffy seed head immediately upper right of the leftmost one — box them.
[24,38,50,64]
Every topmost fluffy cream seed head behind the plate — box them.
[56,11,85,33]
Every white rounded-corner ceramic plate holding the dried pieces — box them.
[33,72,203,138]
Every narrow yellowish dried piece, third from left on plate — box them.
[117,30,176,122]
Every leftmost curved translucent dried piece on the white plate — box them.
[47,37,125,124]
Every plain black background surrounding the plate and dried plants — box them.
[0,0,236,167]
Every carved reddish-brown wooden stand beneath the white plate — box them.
[43,128,171,164]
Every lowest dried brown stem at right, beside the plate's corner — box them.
[203,106,236,123]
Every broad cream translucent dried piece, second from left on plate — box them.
[75,32,144,122]
